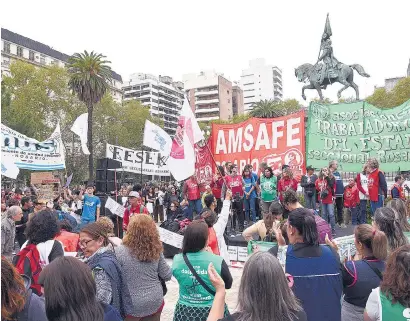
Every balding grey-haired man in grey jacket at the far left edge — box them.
[1,206,23,261]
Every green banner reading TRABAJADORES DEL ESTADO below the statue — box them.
[306,100,410,172]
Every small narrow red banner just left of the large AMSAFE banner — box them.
[195,140,213,192]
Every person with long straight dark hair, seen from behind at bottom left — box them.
[39,255,122,321]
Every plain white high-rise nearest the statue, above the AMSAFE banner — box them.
[241,58,283,112]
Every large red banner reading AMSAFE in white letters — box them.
[212,112,306,176]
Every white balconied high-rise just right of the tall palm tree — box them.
[122,73,184,135]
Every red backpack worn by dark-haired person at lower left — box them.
[13,244,42,296]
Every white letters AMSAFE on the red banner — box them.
[215,117,302,155]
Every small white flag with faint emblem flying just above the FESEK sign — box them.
[144,119,172,156]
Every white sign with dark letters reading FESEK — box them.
[106,144,169,176]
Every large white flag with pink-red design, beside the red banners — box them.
[168,98,204,181]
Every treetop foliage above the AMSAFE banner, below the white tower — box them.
[249,99,302,118]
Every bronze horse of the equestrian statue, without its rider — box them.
[295,63,370,101]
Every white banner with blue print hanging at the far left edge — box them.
[1,124,65,171]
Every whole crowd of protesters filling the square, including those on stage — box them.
[1,159,410,321]
